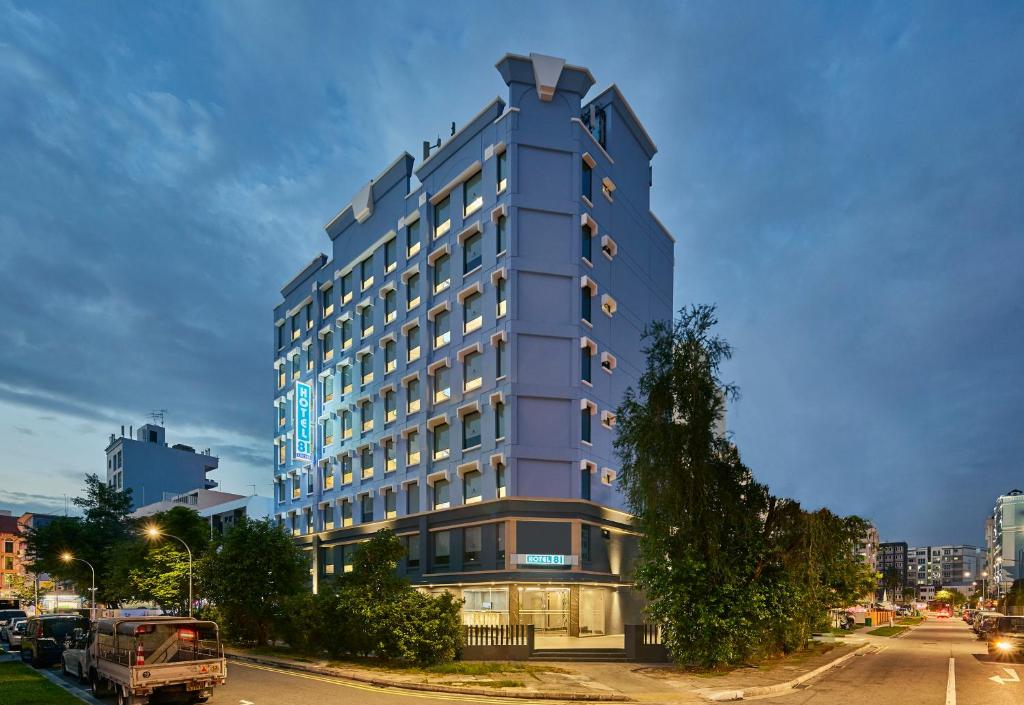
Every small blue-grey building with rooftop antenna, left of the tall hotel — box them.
[106,423,220,509]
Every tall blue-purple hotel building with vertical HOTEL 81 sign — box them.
[273,54,673,636]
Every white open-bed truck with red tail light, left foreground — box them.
[84,617,227,705]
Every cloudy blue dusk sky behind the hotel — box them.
[0,1,1024,543]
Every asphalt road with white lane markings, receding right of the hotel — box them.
[772,618,1024,705]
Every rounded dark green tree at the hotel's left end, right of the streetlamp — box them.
[198,519,309,644]
